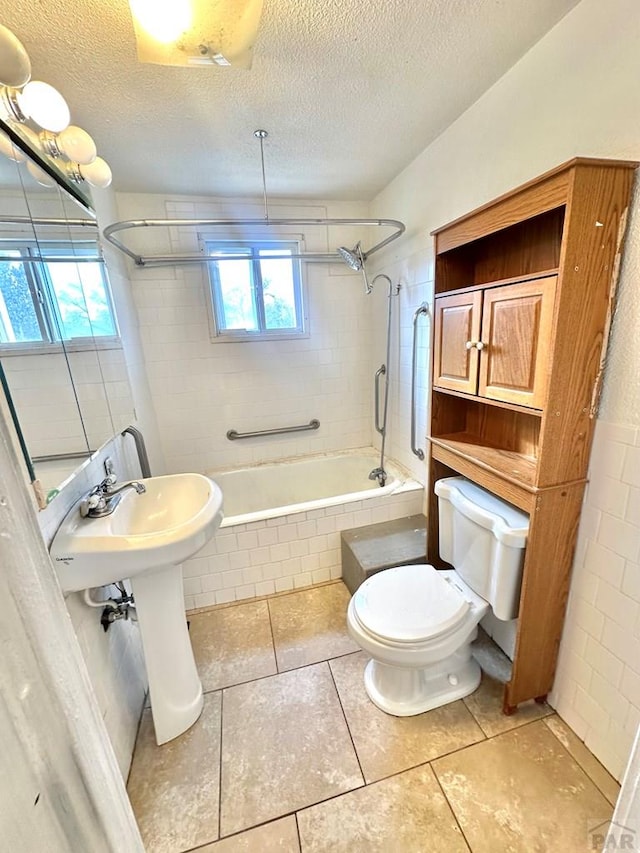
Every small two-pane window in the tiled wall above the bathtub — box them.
[205,240,305,340]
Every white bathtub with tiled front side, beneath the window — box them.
[183,448,424,610]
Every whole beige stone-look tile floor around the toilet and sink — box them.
[128,582,619,853]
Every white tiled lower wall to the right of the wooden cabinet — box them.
[550,420,640,779]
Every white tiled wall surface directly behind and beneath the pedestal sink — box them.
[38,437,147,779]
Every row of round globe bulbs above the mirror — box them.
[0,20,112,187]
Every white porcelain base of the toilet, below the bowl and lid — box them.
[364,648,481,717]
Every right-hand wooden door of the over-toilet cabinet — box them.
[478,276,557,409]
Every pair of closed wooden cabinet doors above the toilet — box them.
[433,276,556,409]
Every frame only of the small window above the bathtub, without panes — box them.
[204,234,309,343]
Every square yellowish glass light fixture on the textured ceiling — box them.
[129,0,263,68]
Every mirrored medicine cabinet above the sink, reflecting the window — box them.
[0,121,134,501]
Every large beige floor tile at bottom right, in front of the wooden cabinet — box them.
[432,720,612,853]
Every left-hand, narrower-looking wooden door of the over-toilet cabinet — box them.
[433,291,482,394]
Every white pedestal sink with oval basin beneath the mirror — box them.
[50,474,223,744]
